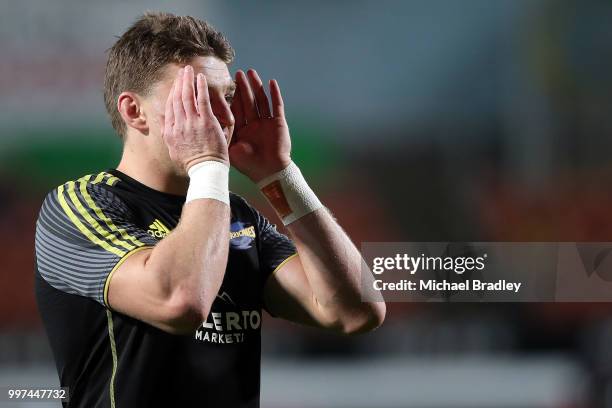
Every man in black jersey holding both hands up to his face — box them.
[36,13,385,408]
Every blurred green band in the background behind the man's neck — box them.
[0,116,342,194]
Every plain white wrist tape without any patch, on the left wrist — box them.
[185,160,229,205]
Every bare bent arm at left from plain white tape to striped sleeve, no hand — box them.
[108,199,230,334]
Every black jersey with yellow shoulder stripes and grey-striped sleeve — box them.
[35,170,295,408]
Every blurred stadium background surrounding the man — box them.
[0,0,612,408]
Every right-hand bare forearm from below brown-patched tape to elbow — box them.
[288,208,385,332]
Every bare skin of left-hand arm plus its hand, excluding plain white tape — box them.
[108,67,230,334]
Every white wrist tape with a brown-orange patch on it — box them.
[257,162,323,225]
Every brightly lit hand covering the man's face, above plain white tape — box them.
[163,65,229,173]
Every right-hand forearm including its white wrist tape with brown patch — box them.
[258,164,385,333]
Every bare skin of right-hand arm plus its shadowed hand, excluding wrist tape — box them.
[230,70,386,333]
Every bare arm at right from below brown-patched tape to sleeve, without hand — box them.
[265,208,386,334]
